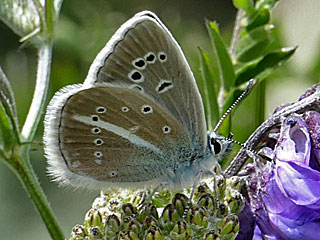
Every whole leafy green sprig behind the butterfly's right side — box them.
[199,0,296,139]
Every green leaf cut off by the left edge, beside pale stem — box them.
[0,68,19,155]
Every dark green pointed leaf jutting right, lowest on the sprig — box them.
[235,47,297,86]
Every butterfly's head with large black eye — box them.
[208,132,233,161]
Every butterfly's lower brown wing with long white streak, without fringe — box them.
[59,87,191,182]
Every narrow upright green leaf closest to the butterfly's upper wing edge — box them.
[199,48,219,130]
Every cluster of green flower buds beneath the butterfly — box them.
[70,176,243,240]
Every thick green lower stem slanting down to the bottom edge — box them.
[7,146,65,240]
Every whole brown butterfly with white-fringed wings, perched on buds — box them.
[44,11,231,189]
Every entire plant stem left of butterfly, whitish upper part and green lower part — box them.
[18,40,64,237]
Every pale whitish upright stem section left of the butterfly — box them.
[21,40,52,141]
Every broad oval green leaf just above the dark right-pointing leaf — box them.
[235,25,273,62]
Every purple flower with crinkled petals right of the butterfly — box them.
[237,106,320,240]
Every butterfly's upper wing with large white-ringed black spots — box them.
[86,12,206,151]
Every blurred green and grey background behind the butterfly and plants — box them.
[0,0,320,240]
